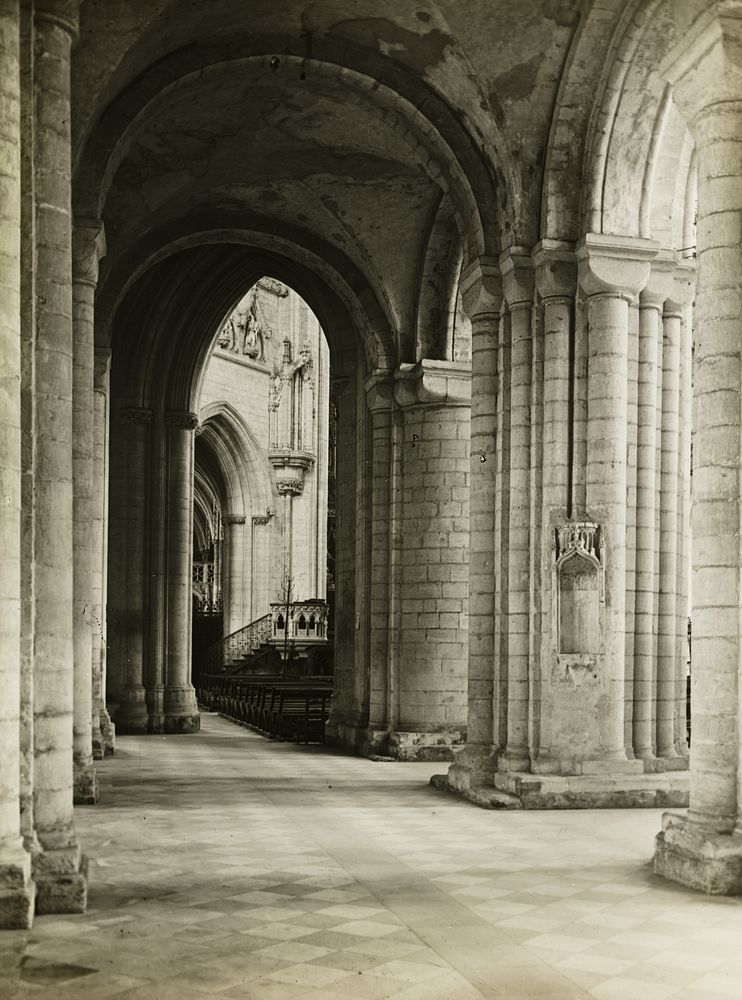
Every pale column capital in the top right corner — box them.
[659,0,742,124]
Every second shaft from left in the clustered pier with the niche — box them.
[498,248,534,771]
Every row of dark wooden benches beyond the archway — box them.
[198,675,332,743]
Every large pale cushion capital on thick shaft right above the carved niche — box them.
[577,233,660,300]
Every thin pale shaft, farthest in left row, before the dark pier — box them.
[91,347,116,760]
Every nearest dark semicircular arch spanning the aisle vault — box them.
[74,34,506,257]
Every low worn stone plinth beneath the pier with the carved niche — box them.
[495,761,689,809]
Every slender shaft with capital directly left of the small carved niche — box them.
[532,240,577,774]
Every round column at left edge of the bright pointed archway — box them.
[165,413,200,733]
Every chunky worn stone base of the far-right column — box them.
[654,813,742,896]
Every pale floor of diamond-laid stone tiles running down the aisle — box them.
[0,715,742,1000]
